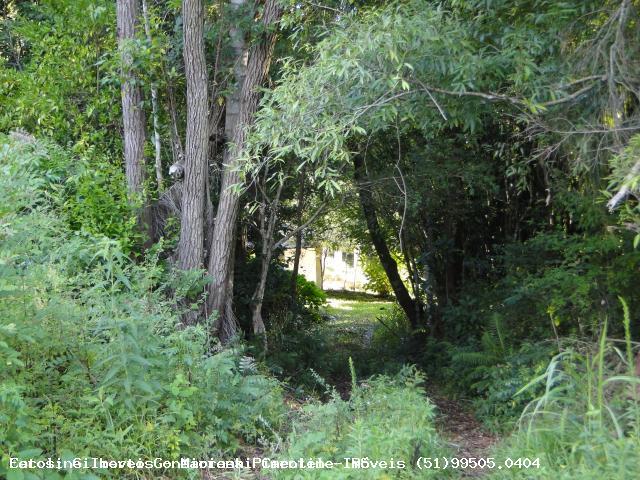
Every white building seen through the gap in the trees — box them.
[284,247,367,291]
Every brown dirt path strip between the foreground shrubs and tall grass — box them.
[427,388,498,478]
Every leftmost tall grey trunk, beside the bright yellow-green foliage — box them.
[116,0,151,240]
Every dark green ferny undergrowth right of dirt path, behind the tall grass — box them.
[430,225,640,430]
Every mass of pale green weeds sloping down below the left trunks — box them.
[0,138,284,478]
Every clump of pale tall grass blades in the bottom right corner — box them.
[484,311,640,480]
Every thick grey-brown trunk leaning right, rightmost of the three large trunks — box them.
[208,0,282,342]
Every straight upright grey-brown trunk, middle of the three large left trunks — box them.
[178,0,208,270]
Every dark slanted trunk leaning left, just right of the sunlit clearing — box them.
[353,155,421,329]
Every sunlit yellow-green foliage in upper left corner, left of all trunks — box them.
[0,0,119,152]
